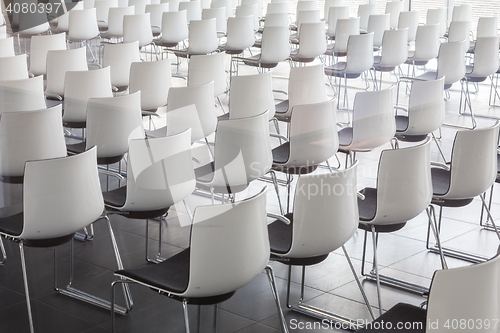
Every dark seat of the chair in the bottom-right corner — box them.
[357,303,427,333]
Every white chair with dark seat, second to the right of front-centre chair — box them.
[358,139,432,315]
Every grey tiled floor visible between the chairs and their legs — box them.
[0,42,500,333]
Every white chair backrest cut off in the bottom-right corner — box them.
[426,255,500,333]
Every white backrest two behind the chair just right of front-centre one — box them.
[287,64,328,113]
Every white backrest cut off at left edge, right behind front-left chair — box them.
[0,105,66,178]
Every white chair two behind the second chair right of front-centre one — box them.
[325,32,373,109]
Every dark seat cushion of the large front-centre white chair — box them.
[115,248,190,293]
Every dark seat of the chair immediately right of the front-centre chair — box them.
[267,213,328,266]
